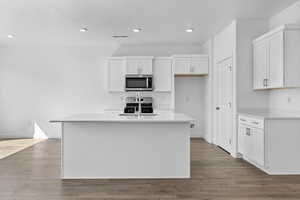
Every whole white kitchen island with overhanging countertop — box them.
[50,112,193,179]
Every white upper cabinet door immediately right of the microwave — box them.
[153,59,172,92]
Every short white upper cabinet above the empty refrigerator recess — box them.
[173,55,209,75]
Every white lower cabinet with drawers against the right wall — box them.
[237,114,300,175]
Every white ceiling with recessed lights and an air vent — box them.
[0,0,297,45]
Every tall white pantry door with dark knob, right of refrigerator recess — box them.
[216,58,233,152]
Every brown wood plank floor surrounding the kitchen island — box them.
[0,140,300,200]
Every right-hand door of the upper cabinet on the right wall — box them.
[268,32,284,88]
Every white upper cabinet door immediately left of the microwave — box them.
[108,59,125,92]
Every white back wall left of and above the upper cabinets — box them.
[0,44,200,138]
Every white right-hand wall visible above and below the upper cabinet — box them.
[269,1,300,111]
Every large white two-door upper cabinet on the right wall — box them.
[253,25,300,90]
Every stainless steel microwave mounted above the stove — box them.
[125,75,153,91]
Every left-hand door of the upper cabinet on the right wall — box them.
[253,41,269,89]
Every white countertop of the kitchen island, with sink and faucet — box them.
[50,112,195,123]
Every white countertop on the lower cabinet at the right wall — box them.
[238,109,300,119]
